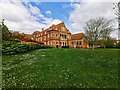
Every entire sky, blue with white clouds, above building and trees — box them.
[0,0,118,38]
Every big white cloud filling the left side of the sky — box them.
[0,0,61,33]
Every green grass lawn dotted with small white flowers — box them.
[2,48,118,88]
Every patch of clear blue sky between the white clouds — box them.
[26,2,73,23]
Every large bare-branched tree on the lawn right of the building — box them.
[84,17,113,49]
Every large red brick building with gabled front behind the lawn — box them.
[31,22,89,48]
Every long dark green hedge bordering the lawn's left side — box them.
[2,41,52,55]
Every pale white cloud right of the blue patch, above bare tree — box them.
[68,0,117,38]
